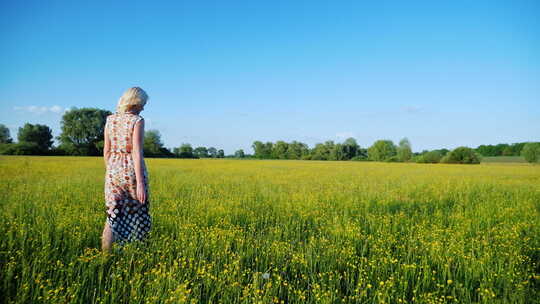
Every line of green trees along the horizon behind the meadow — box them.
[0,108,540,164]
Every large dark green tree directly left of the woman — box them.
[58,108,111,155]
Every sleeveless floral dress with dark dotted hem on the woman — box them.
[105,113,152,243]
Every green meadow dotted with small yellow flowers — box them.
[0,156,540,303]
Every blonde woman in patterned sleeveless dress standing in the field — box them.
[101,87,151,252]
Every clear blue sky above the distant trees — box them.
[0,0,540,154]
